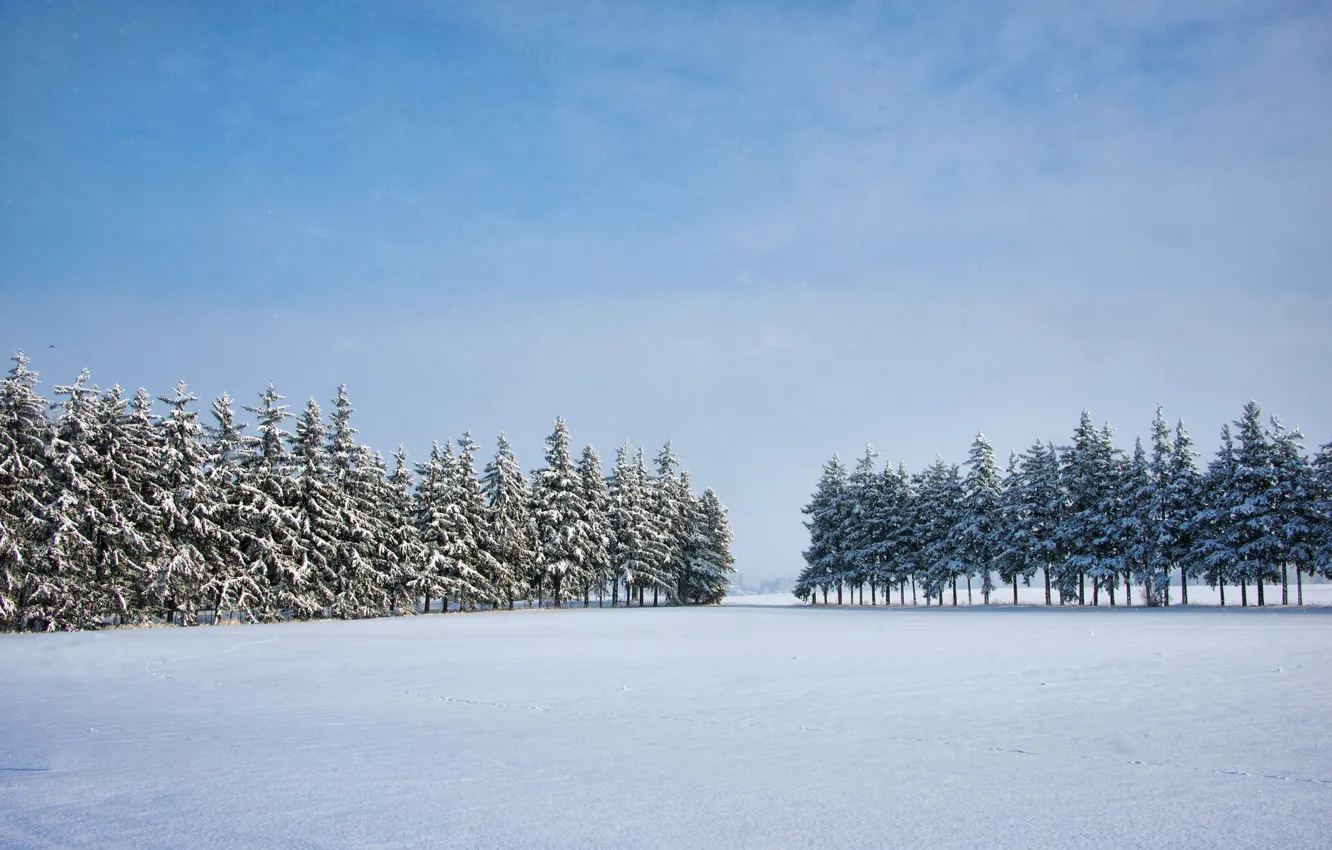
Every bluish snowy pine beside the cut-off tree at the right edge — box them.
[1268,416,1319,605]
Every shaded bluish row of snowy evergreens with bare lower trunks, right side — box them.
[797,401,1332,605]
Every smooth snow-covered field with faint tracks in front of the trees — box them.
[0,607,1332,849]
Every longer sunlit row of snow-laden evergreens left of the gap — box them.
[0,352,733,630]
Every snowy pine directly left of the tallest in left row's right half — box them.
[482,432,537,609]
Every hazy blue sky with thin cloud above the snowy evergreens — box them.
[0,0,1332,580]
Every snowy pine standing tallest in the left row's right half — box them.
[531,418,586,608]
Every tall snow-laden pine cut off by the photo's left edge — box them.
[0,350,55,630]
